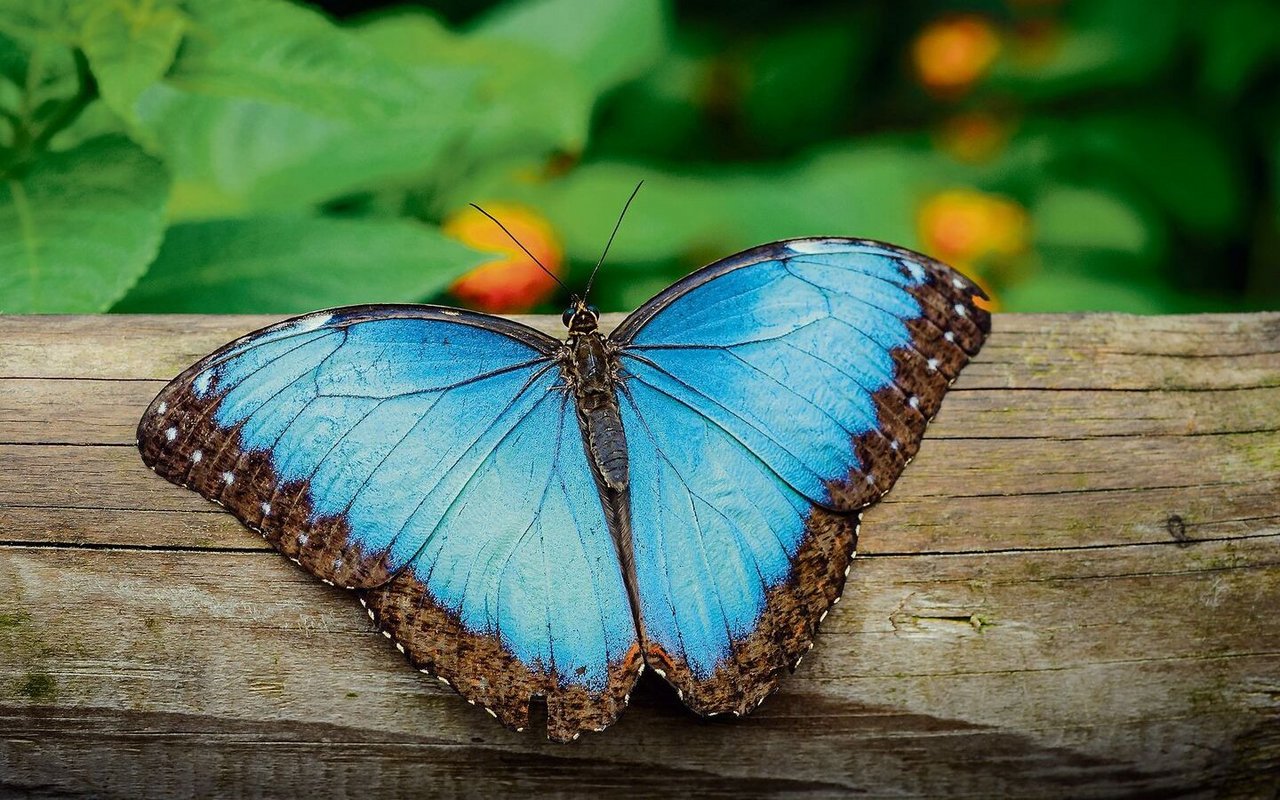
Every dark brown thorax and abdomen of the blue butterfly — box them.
[563,329,627,492]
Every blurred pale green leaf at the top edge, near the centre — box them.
[472,0,668,95]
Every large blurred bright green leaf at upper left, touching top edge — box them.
[136,0,470,219]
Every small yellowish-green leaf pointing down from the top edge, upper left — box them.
[79,0,187,133]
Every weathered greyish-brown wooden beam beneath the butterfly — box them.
[0,314,1280,797]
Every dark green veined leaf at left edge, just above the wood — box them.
[0,137,168,314]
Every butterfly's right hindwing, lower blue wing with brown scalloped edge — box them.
[622,380,856,714]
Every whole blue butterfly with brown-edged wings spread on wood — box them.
[138,238,989,741]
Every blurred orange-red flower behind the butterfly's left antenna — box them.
[442,202,564,314]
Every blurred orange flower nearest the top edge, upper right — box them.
[911,14,1000,95]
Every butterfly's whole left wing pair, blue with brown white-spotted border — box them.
[138,306,641,739]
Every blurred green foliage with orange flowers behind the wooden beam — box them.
[0,0,1280,314]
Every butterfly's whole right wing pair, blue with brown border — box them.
[611,238,989,714]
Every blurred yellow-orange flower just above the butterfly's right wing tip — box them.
[916,188,1030,307]
